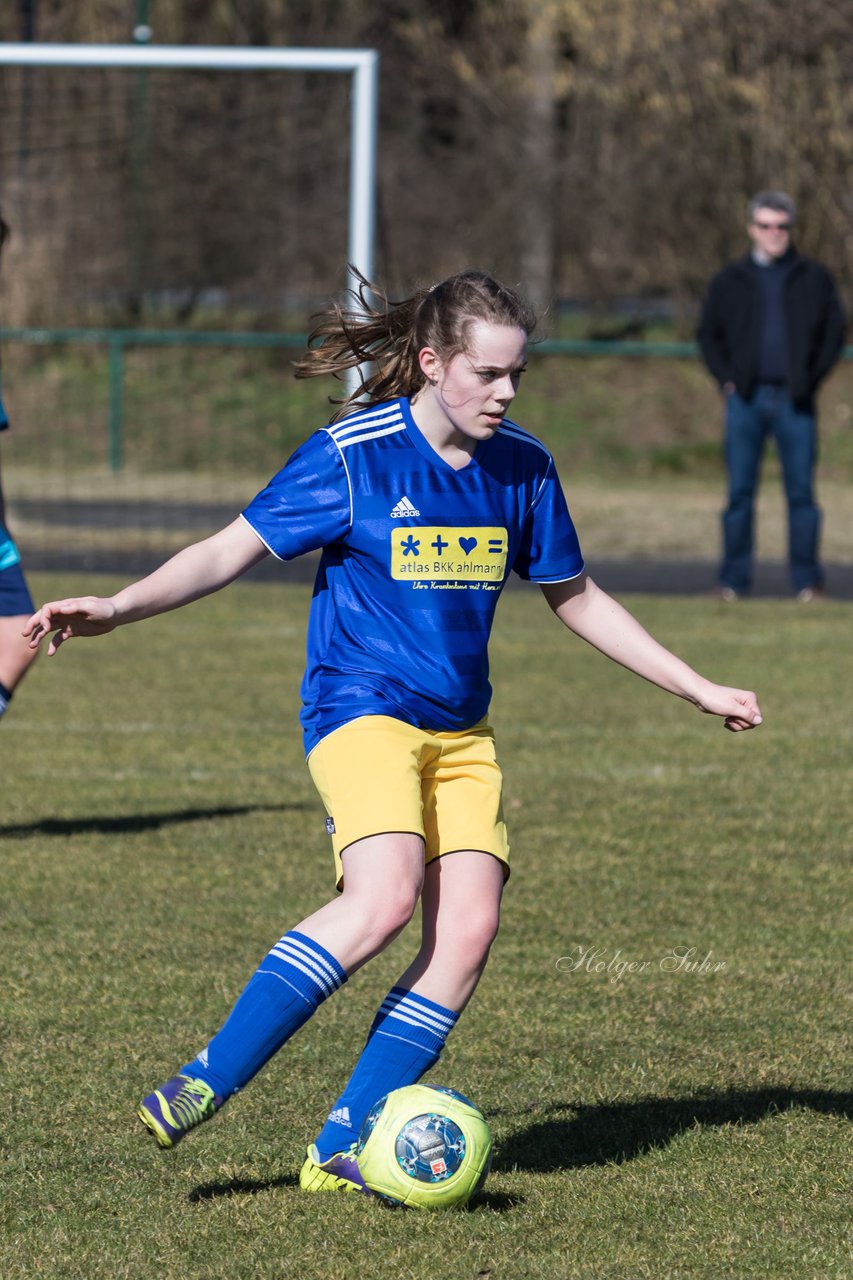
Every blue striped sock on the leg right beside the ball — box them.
[316,987,459,1160]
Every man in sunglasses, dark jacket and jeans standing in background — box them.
[697,191,844,602]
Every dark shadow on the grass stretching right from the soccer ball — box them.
[492,1088,853,1172]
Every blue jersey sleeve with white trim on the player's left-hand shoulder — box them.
[236,431,352,559]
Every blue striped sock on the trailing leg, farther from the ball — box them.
[181,931,347,1106]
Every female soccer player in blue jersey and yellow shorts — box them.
[27,271,761,1190]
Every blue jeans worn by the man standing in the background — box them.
[720,387,824,594]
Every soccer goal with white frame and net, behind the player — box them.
[0,46,375,567]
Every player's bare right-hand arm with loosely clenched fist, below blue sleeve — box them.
[542,573,761,733]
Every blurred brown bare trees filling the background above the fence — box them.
[0,0,853,322]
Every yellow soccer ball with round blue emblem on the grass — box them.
[356,1084,492,1208]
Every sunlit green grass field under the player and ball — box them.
[0,576,853,1280]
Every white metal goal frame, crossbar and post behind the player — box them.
[0,42,379,390]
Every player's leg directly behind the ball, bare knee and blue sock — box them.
[308,851,506,1172]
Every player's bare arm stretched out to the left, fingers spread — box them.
[23,520,269,655]
